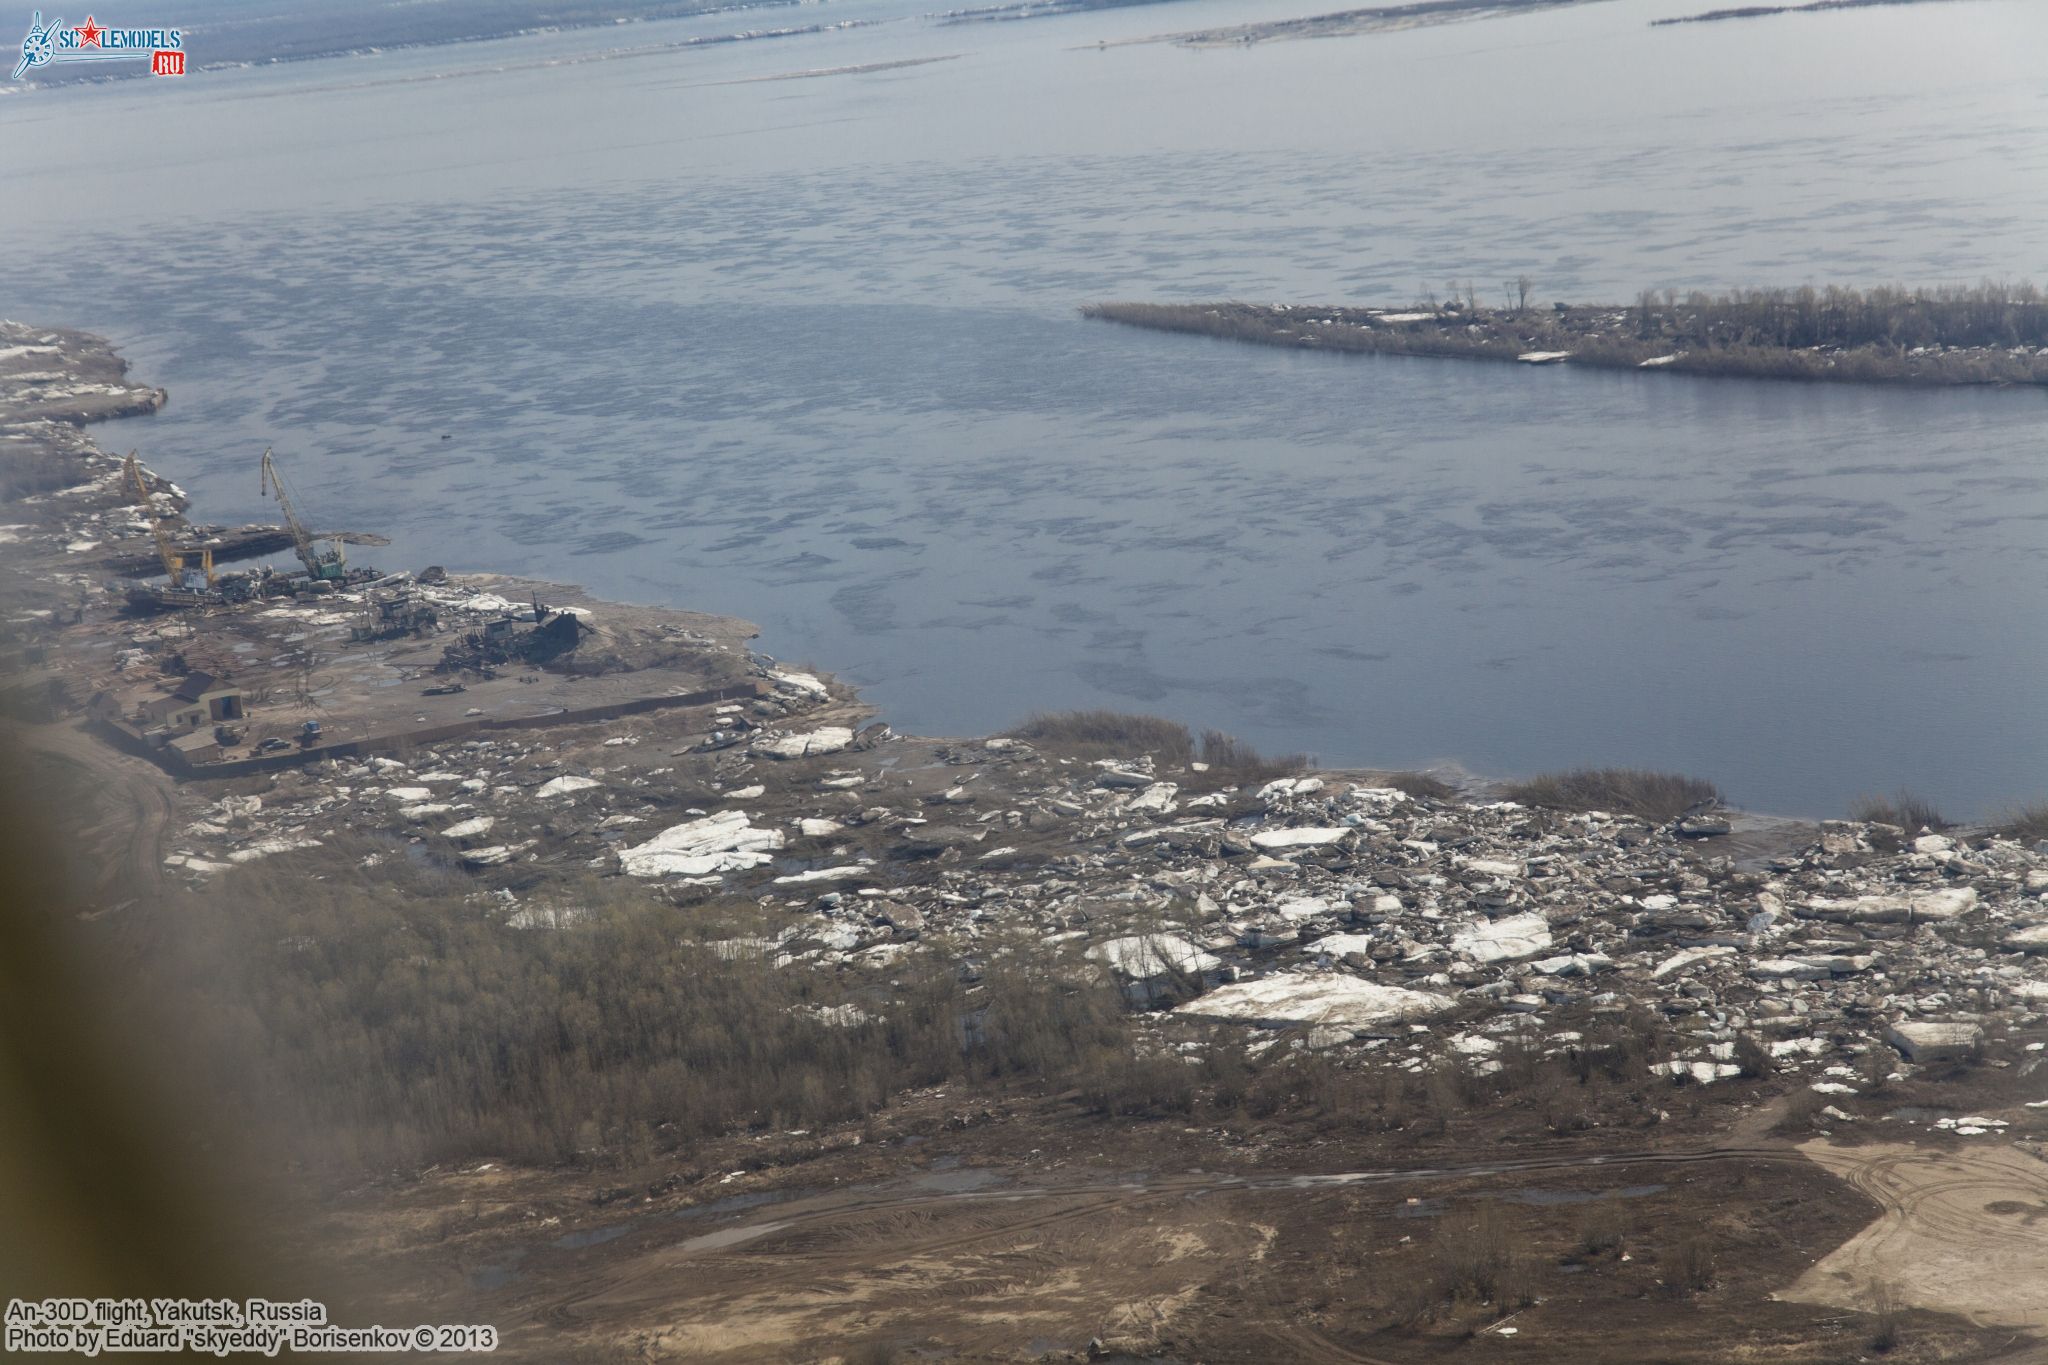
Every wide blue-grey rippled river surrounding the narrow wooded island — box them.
[0,0,2048,814]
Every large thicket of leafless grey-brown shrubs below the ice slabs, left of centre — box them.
[109,879,1155,1179]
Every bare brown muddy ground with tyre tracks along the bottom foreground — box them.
[260,1093,2048,1363]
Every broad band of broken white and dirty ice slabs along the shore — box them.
[168,687,2048,1132]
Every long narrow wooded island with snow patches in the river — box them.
[1081,280,2048,385]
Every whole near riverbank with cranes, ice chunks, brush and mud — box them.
[0,323,2048,1361]
